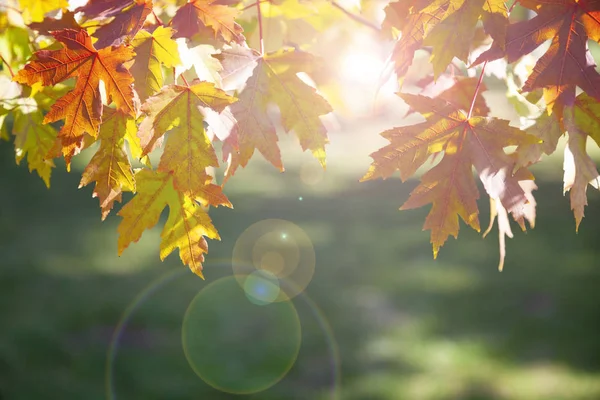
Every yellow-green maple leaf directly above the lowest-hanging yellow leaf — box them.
[138,81,235,197]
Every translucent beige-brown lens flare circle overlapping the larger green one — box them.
[232,219,316,302]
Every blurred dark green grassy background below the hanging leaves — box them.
[0,98,600,400]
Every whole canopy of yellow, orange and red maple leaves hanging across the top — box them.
[0,0,600,276]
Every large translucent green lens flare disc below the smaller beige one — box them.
[182,275,302,394]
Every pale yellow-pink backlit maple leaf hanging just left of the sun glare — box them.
[215,46,332,176]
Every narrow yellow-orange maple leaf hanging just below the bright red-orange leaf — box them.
[79,107,139,220]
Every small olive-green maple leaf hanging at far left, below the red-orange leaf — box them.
[12,107,56,188]
